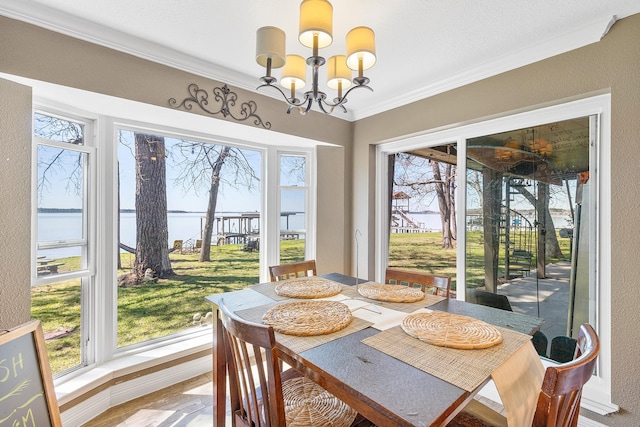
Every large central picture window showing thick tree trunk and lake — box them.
[117,128,261,347]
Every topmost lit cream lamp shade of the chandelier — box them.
[298,0,333,48]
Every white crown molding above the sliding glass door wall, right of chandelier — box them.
[354,16,617,120]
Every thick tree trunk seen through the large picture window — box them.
[134,133,173,280]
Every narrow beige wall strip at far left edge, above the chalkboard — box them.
[0,79,31,330]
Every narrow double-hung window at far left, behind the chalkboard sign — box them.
[31,112,95,374]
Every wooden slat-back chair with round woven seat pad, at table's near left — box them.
[218,300,363,427]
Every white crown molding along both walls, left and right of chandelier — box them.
[0,0,616,121]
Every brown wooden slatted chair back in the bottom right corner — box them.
[533,324,600,427]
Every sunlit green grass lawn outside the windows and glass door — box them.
[31,232,569,373]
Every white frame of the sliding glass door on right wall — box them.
[375,94,619,415]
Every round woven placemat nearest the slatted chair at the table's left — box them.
[262,301,353,337]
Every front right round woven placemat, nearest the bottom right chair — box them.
[401,311,502,350]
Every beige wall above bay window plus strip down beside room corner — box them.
[0,17,353,283]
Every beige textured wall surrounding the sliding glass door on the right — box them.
[353,15,640,426]
